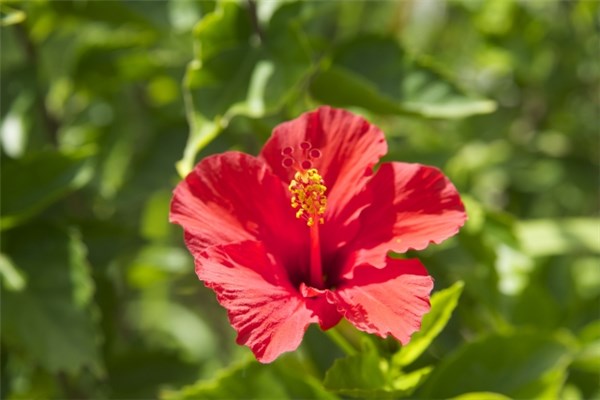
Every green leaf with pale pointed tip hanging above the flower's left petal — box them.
[177,2,312,176]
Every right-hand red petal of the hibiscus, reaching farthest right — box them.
[348,162,467,266]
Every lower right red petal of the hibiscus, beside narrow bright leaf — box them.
[328,258,433,344]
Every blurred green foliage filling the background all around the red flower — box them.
[0,0,600,400]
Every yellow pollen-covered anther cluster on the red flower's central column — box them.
[288,168,327,226]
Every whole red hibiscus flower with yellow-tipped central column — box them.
[170,107,466,363]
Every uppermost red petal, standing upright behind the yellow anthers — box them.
[260,107,387,252]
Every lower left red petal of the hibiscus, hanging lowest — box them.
[196,242,318,363]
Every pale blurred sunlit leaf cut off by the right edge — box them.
[517,218,600,257]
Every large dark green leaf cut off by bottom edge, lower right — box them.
[420,331,573,399]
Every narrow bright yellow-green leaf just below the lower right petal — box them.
[392,281,464,366]
